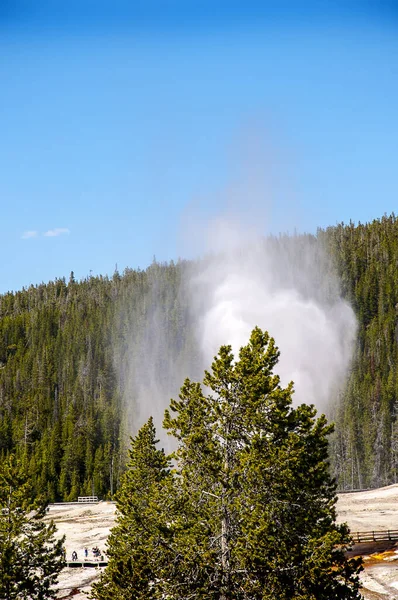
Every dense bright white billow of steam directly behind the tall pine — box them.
[190,219,356,410]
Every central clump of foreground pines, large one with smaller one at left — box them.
[94,328,361,600]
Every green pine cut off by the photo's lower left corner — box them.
[0,455,65,600]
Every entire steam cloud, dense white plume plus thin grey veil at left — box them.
[116,153,356,440]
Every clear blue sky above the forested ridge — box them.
[0,0,398,293]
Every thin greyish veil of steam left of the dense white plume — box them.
[114,263,199,451]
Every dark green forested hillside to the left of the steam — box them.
[0,263,193,501]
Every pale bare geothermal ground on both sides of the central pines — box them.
[47,485,398,600]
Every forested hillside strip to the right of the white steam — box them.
[318,215,398,489]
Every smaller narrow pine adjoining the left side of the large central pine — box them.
[92,418,172,600]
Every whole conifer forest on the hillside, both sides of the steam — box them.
[0,215,398,501]
